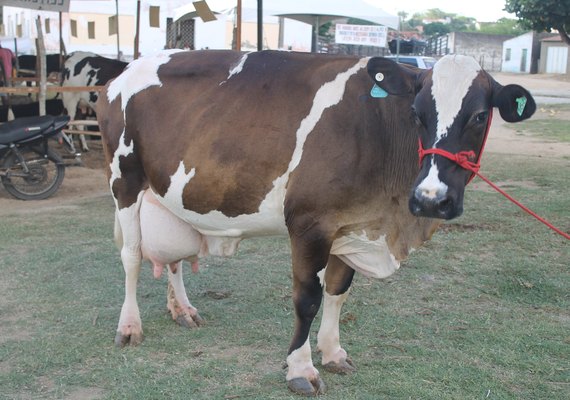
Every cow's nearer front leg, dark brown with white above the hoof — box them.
[286,228,330,396]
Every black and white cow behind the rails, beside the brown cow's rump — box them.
[61,51,127,151]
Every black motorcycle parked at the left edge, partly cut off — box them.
[0,115,70,200]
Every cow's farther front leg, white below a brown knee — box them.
[317,256,356,374]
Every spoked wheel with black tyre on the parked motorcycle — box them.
[2,148,65,200]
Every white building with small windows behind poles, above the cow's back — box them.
[2,0,311,60]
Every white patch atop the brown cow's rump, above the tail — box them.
[107,49,184,111]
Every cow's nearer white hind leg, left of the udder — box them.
[115,192,143,347]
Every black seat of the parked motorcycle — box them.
[0,115,69,144]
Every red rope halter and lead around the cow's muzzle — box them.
[418,109,570,240]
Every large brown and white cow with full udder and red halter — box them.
[98,51,535,395]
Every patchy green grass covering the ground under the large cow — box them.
[0,154,570,400]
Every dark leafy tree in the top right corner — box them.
[505,0,570,45]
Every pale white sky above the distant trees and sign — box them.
[365,0,516,22]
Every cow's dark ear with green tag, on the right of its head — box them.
[493,83,536,122]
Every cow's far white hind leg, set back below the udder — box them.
[166,261,204,328]
